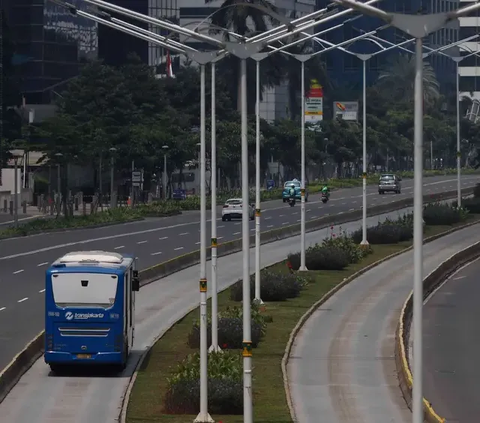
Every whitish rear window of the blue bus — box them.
[52,273,118,308]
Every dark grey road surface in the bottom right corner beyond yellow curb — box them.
[423,256,480,423]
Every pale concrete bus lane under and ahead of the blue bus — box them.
[0,209,430,423]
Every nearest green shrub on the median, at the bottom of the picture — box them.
[165,351,243,414]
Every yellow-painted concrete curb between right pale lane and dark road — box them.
[395,238,480,423]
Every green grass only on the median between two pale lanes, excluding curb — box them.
[127,210,480,423]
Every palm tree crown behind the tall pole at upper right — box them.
[378,54,440,105]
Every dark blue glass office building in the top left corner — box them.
[4,0,98,104]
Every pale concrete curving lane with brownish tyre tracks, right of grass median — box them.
[288,225,477,423]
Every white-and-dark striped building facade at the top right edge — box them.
[459,1,480,100]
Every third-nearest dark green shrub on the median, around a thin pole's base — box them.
[230,270,305,301]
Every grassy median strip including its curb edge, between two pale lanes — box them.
[120,201,479,423]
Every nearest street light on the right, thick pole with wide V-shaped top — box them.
[334,0,480,423]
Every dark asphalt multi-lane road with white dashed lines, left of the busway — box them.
[0,175,480,369]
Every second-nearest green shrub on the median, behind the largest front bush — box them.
[187,304,267,349]
